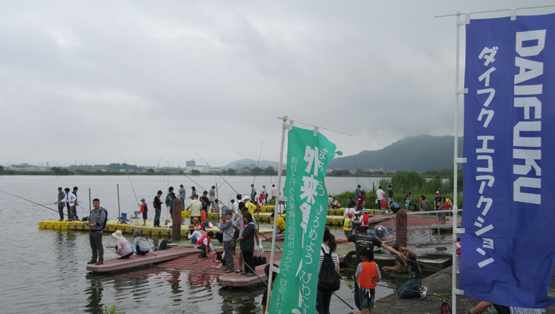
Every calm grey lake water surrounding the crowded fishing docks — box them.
[0,176,444,314]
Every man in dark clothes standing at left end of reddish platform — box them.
[85,198,108,265]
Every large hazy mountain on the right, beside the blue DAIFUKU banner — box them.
[328,134,463,172]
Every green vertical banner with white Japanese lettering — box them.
[270,127,336,314]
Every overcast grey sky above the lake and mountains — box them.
[0,0,555,166]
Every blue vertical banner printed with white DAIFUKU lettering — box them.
[460,14,555,308]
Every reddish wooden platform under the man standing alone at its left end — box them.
[87,246,198,273]
